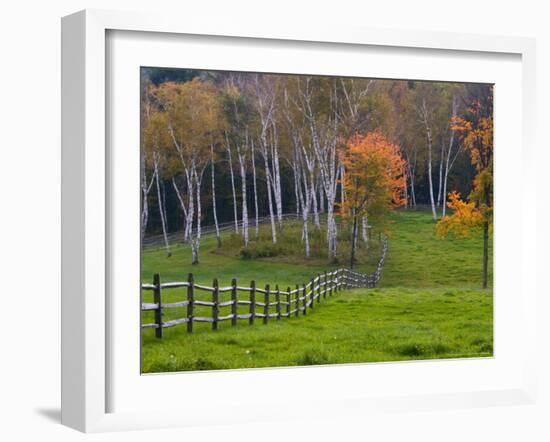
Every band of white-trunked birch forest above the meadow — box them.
[141,68,492,263]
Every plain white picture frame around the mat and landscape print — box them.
[62,10,537,432]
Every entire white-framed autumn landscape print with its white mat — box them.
[62,11,536,431]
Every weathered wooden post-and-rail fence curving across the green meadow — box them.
[141,238,388,338]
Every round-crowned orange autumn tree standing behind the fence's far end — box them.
[341,132,405,268]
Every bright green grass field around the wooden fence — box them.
[142,210,493,373]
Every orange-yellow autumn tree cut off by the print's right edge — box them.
[437,87,493,288]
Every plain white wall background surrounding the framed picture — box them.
[0,0,550,442]
